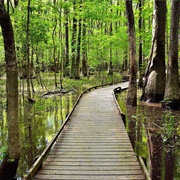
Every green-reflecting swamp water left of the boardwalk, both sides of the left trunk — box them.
[0,82,82,180]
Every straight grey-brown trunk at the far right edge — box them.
[164,0,180,106]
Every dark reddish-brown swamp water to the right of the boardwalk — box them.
[117,91,180,180]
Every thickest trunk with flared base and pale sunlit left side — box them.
[141,0,166,102]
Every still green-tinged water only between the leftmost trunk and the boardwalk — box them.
[18,93,78,177]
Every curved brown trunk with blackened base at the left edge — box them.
[0,0,21,180]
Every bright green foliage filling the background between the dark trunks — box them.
[0,0,174,73]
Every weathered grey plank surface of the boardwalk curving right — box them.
[35,83,145,180]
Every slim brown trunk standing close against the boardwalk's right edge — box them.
[126,0,137,106]
